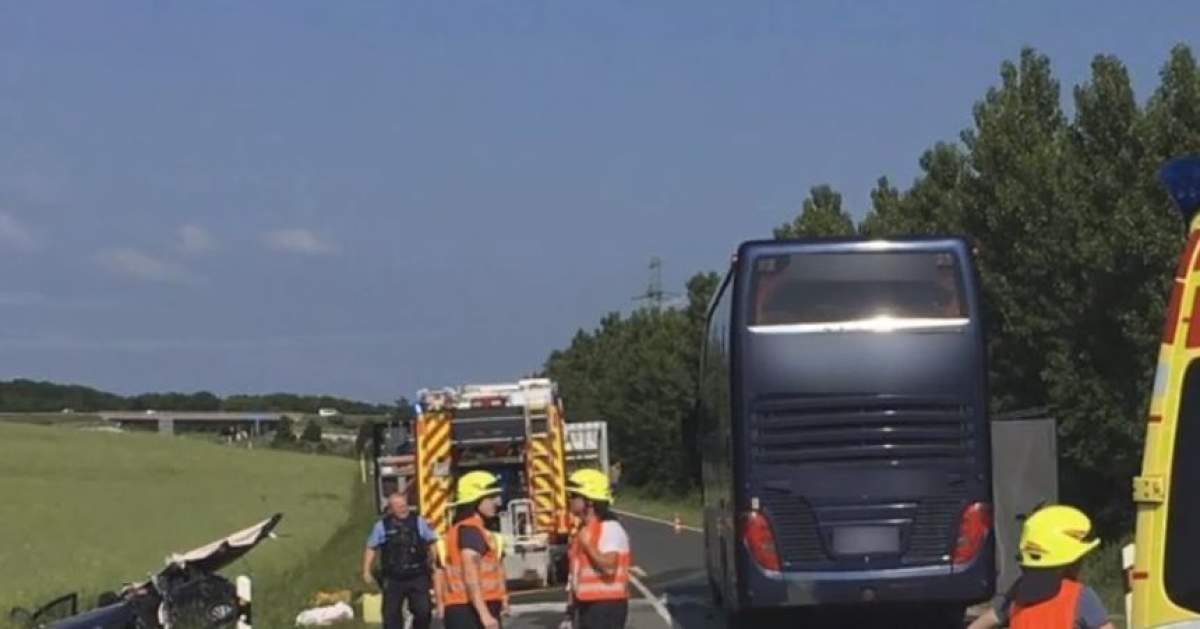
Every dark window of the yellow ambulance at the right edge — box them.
[1163,360,1200,611]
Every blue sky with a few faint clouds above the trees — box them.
[0,0,1200,401]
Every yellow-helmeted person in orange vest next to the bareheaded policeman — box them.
[442,471,505,629]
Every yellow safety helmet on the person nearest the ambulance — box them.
[1020,504,1100,568]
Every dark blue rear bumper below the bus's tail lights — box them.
[744,561,995,609]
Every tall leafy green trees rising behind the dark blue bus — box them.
[546,44,1200,533]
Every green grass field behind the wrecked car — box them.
[0,423,360,627]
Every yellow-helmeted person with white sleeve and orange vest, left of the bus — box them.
[566,469,632,629]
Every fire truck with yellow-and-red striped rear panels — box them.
[374,378,570,586]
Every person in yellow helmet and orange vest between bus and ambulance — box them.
[970,504,1114,629]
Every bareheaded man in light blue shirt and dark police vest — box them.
[362,491,438,629]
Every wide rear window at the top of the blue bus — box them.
[750,251,967,325]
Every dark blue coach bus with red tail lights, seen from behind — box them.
[697,238,996,627]
